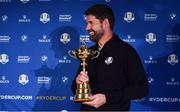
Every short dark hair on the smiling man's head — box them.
[85,4,115,30]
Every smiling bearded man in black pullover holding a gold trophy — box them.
[72,4,148,111]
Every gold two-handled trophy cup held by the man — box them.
[68,42,99,102]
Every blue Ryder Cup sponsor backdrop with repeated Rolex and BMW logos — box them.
[0,0,180,111]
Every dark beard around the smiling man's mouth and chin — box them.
[88,30,104,42]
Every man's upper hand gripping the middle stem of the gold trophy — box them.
[76,71,89,84]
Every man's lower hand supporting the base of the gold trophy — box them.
[83,94,106,108]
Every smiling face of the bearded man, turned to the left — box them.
[86,15,104,42]
